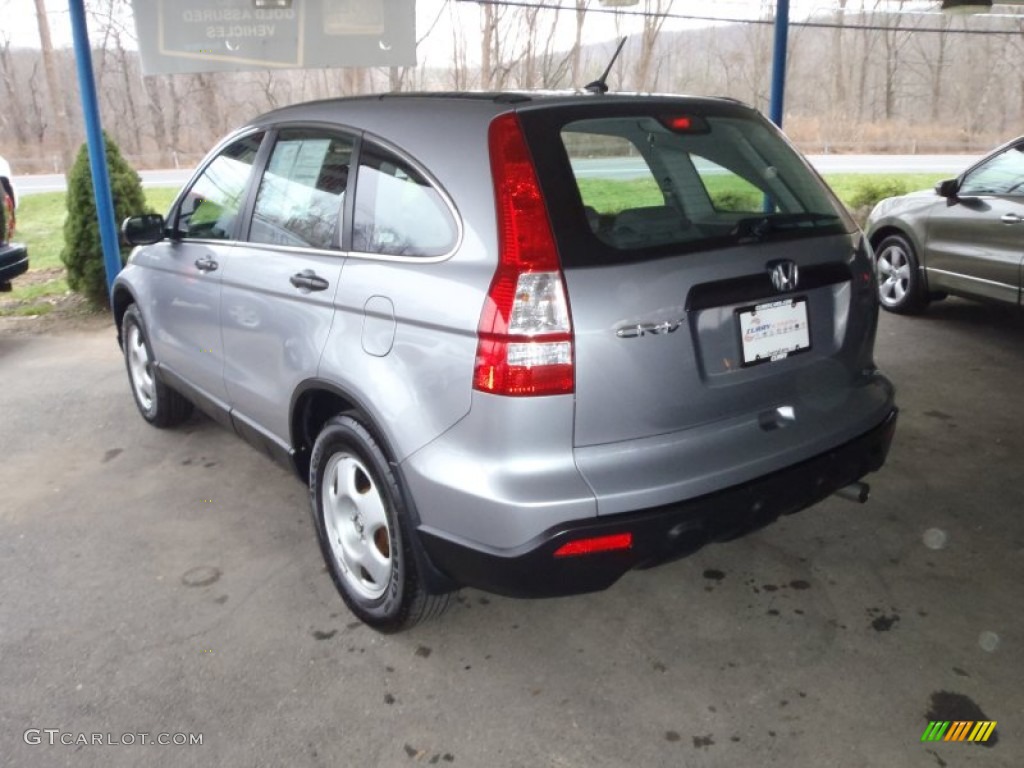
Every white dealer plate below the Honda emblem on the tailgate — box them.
[736,298,811,366]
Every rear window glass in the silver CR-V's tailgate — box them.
[560,115,846,251]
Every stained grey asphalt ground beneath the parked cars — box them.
[0,300,1024,768]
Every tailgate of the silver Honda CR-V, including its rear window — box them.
[520,105,870,446]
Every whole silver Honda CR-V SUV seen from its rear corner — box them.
[113,94,896,631]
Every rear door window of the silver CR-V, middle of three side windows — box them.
[249,130,354,249]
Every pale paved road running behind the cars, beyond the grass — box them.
[14,155,981,195]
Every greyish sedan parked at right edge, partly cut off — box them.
[866,137,1024,314]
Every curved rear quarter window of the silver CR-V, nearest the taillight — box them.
[352,142,458,257]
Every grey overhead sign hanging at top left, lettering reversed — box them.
[132,0,416,75]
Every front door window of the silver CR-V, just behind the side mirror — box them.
[174,133,263,240]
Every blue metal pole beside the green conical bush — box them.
[68,0,121,307]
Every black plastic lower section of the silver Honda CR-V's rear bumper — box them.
[418,409,897,597]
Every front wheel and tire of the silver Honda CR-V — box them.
[121,304,193,428]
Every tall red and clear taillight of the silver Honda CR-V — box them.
[473,114,574,396]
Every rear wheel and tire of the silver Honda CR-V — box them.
[309,412,451,633]
